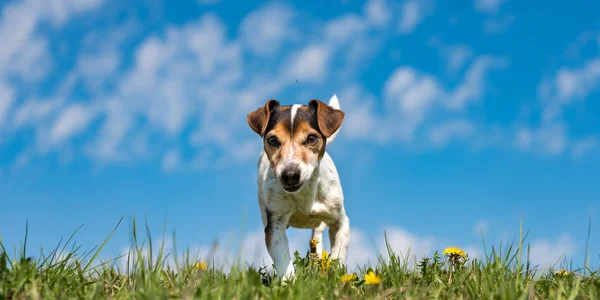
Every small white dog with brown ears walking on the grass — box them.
[247,94,350,281]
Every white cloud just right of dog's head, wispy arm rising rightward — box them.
[340,55,508,147]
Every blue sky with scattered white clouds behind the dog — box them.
[0,0,600,267]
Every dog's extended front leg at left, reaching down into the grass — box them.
[265,213,294,280]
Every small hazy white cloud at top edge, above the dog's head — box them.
[240,3,297,55]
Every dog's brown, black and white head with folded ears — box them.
[248,98,344,193]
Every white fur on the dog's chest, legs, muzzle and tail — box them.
[257,95,350,280]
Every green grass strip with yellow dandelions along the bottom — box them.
[0,219,600,299]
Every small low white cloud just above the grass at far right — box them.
[530,233,577,268]
